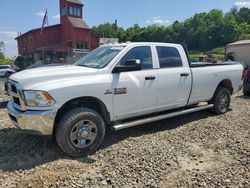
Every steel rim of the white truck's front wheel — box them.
[70,120,97,149]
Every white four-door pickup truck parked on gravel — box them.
[7,43,243,157]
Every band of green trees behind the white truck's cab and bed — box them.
[92,7,250,51]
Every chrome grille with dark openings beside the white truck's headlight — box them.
[8,80,26,111]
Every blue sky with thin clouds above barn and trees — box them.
[0,0,250,58]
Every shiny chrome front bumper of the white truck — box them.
[7,102,57,135]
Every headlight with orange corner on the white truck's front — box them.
[24,91,55,107]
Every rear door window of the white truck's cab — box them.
[156,46,183,68]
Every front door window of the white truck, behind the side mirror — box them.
[120,46,153,70]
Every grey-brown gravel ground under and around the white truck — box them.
[0,78,250,187]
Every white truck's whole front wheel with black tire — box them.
[56,108,105,157]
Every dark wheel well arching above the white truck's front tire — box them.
[54,97,110,127]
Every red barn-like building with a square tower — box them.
[16,0,98,63]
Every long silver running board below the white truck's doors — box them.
[113,104,214,131]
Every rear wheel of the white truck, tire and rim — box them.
[209,87,231,115]
